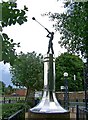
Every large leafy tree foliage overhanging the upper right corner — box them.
[49,1,88,57]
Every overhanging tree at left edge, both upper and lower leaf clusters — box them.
[0,1,28,65]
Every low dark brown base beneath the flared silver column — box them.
[28,111,70,120]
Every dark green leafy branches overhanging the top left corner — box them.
[1,2,28,27]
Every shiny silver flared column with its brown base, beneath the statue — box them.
[28,54,70,120]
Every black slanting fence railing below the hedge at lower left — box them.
[2,109,25,120]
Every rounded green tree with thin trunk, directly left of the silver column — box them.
[10,52,43,103]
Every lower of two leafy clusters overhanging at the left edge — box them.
[2,33,20,65]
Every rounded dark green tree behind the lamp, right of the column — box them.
[55,53,84,91]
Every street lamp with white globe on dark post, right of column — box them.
[64,72,69,109]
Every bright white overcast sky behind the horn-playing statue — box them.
[4,0,64,56]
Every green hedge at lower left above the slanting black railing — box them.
[2,103,25,119]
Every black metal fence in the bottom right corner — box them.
[76,105,88,120]
